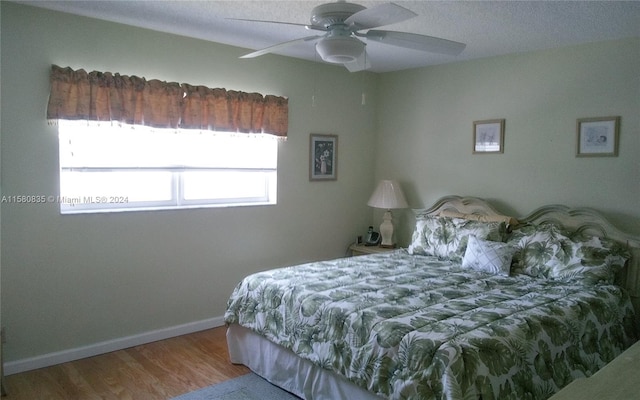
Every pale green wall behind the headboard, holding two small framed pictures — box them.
[376,38,640,244]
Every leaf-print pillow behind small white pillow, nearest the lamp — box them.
[407,215,506,262]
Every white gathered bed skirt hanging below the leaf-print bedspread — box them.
[227,324,382,400]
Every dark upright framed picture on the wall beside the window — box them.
[309,133,338,181]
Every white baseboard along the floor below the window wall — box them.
[4,317,224,375]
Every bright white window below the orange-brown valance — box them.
[59,120,278,214]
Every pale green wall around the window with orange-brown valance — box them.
[1,2,376,370]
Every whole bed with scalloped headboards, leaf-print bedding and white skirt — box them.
[225,196,640,400]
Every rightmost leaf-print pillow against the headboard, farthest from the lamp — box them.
[551,237,631,284]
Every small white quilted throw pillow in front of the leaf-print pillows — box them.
[462,235,516,276]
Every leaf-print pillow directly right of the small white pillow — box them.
[507,224,571,278]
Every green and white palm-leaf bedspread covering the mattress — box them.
[225,250,636,400]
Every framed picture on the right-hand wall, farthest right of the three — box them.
[576,117,620,157]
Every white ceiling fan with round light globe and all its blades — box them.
[231,0,466,72]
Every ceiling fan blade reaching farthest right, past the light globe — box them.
[359,30,467,56]
